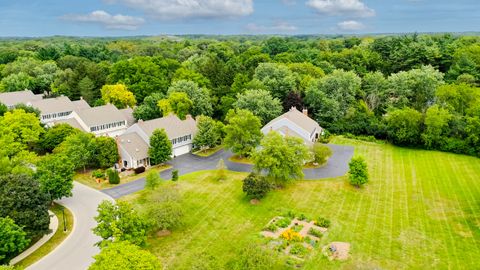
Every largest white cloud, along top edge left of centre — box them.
[105,0,253,20]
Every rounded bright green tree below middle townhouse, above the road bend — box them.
[53,132,95,171]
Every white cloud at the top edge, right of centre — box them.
[307,0,375,18]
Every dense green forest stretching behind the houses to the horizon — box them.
[0,34,480,156]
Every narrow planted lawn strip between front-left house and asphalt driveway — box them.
[73,164,172,190]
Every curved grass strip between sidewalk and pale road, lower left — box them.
[15,203,73,269]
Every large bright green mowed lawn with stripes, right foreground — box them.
[124,138,480,269]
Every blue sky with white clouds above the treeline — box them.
[0,0,480,37]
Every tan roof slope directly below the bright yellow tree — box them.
[78,104,127,127]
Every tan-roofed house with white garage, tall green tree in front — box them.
[117,114,197,169]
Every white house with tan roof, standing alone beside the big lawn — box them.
[262,107,323,145]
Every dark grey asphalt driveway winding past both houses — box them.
[102,144,354,198]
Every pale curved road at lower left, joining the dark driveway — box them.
[27,182,113,270]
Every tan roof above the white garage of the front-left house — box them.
[137,114,197,139]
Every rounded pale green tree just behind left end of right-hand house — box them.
[233,90,282,124]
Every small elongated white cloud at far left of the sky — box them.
[62,10,145,30]
